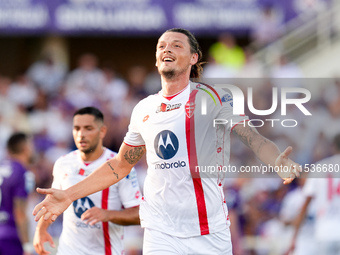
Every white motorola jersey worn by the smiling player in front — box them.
[124,84,246,237]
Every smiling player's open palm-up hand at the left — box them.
[33,188,72,221]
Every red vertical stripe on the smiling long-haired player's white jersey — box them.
[185,90,209,235]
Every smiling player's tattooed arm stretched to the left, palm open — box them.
[33,143,145,221]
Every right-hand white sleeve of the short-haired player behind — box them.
[118,168,142,208]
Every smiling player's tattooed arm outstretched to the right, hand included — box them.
[233,125,301,184]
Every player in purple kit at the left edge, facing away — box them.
[0,133,34,255]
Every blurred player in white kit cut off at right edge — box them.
[290,134,340,255]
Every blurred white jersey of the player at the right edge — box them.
[303,154,340,242]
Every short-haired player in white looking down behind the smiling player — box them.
[33,107,141,255]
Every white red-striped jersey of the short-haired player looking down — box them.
[52,149,141,255]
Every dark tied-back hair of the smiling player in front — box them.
[165,28,204,79]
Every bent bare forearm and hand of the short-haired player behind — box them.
[81,206,140,226]
